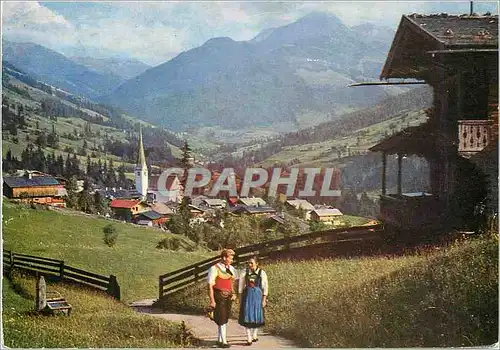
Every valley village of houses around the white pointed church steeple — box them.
[3,137,350,227]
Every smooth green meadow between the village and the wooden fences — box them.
[2,200,213,302]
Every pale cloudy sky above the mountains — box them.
[2,1,498,66]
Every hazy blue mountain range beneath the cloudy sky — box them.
[3,12,403,131]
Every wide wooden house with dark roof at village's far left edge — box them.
[3,171,67,207]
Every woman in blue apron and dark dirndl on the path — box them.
[238,257,268,345]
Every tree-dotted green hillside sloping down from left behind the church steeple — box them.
[2,61,188,187]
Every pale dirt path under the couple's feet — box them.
[130,299,296,349]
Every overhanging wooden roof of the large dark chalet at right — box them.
[380,14,498,80]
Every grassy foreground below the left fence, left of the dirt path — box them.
[2,276,191,348]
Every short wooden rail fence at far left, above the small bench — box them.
[3,250,120,300]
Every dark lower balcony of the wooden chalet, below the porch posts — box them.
[380,192,445,230]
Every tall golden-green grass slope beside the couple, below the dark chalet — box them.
[169,238,498,348]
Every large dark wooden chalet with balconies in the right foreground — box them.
[370,14,498,230]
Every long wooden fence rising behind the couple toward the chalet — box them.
[158,224,383,301]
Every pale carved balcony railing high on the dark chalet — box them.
[458,119,493,157]
